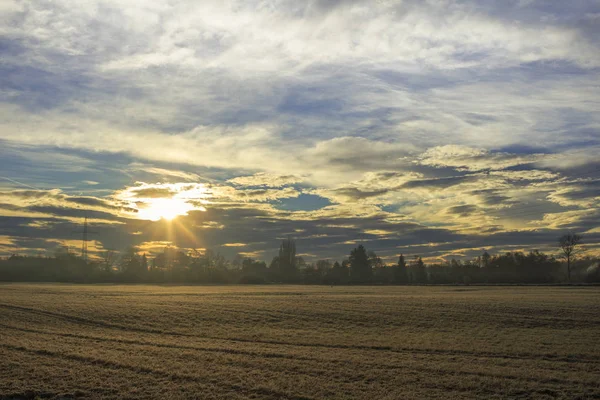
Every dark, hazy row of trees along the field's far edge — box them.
[0,234,600,285]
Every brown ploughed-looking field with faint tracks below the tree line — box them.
[0,284,600,399]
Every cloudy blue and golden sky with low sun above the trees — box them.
[0,0,600,262]
